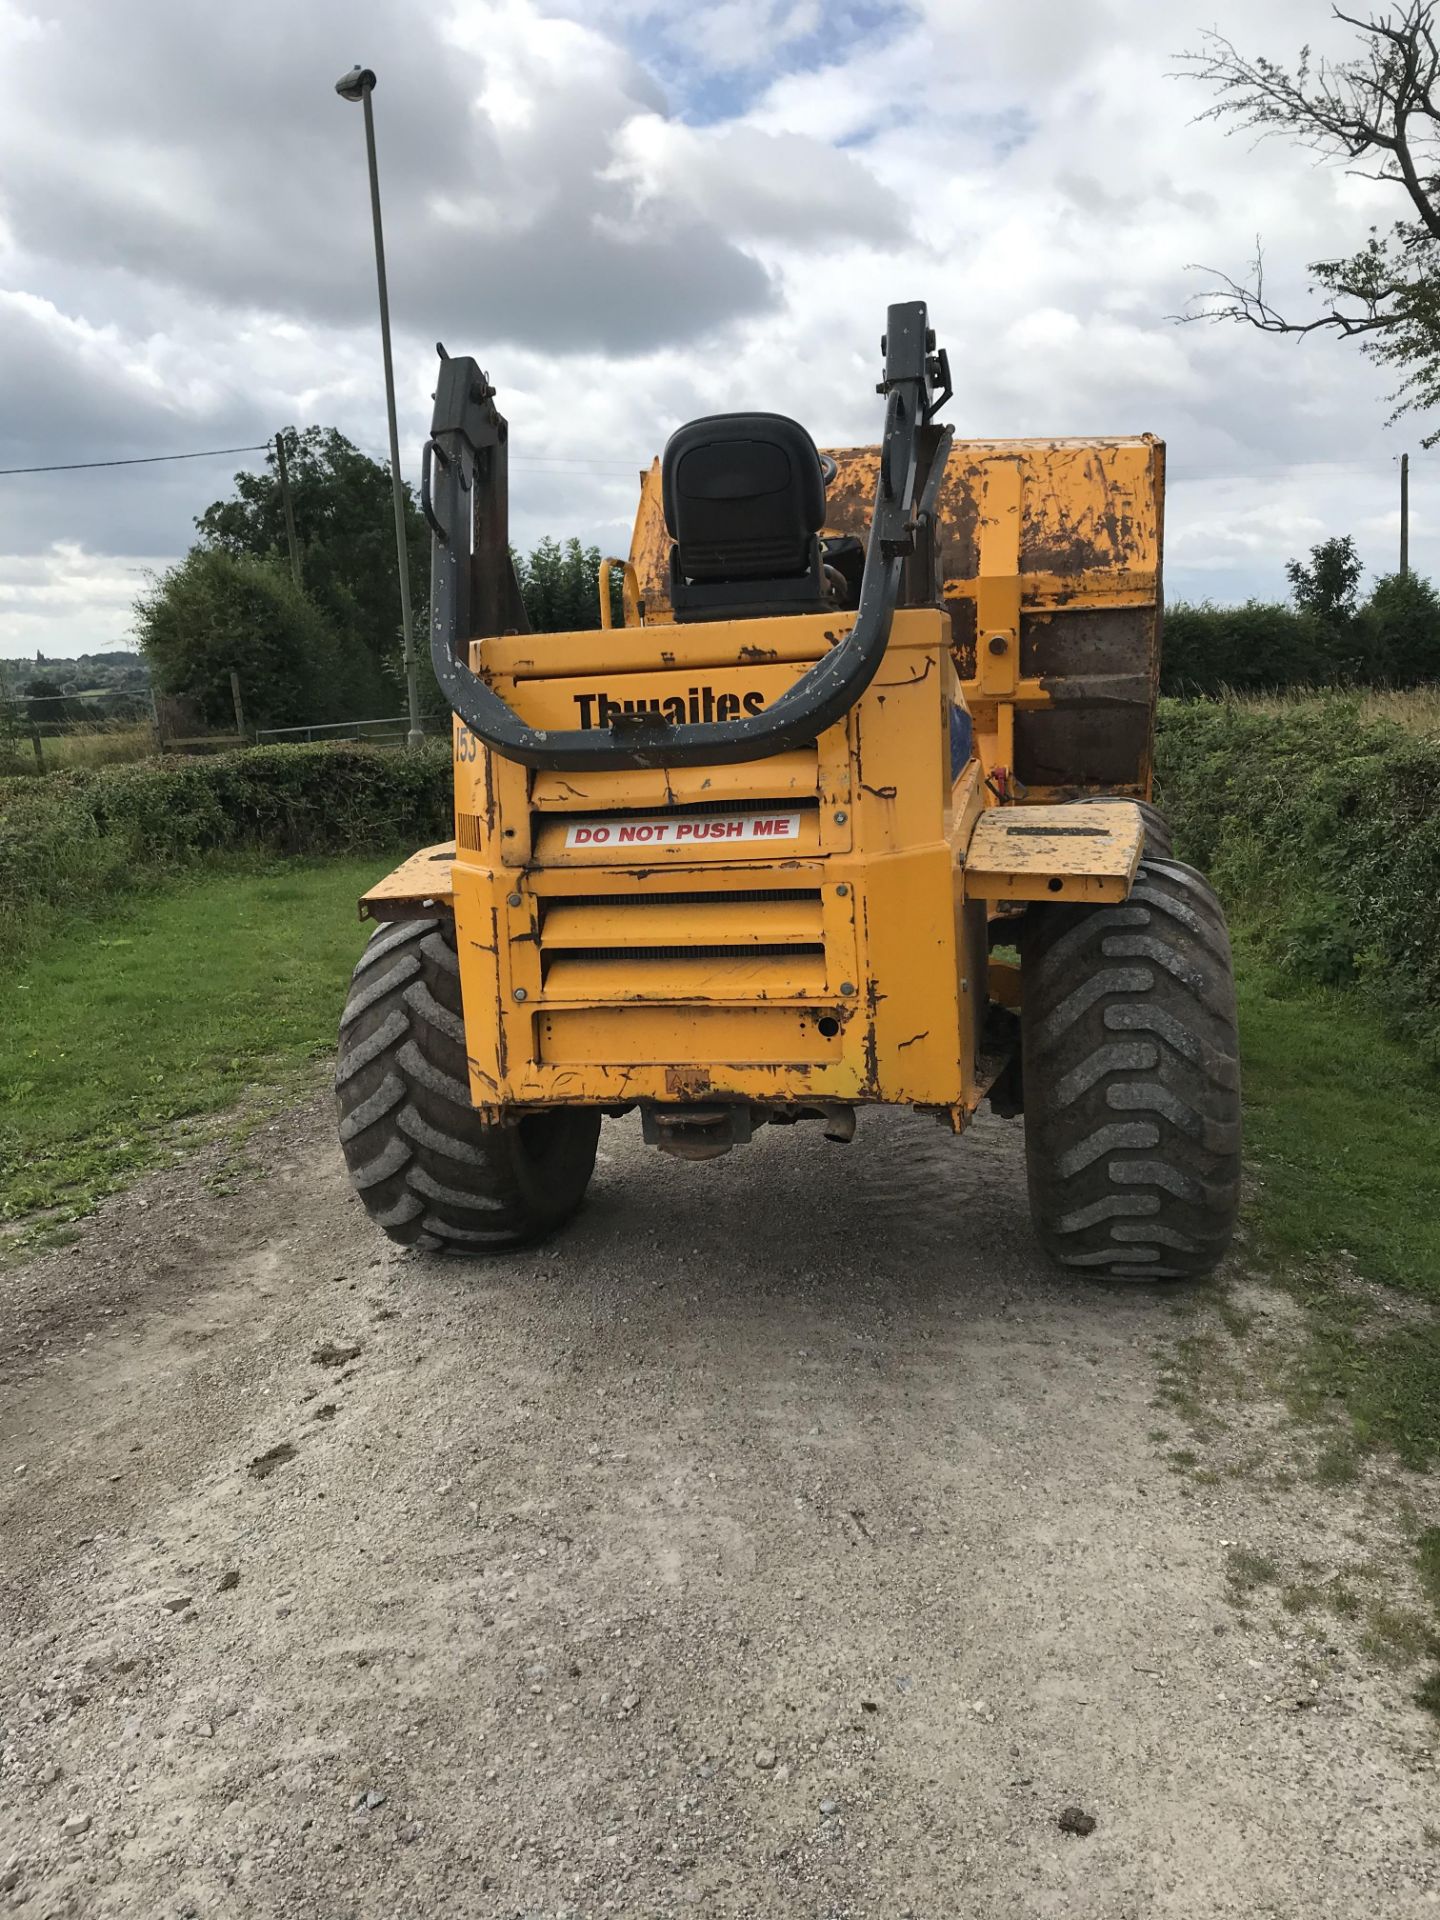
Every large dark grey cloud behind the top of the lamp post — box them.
[0,0,774,353]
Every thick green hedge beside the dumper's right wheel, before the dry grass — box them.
[1156,695,1440,1064]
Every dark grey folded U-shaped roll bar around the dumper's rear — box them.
[420,300,950,774]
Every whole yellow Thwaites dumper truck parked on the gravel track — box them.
[336,301,1240,1281]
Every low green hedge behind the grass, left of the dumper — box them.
[0,741,451,956]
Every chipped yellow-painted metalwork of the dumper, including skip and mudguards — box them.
[361,420,1164,1127]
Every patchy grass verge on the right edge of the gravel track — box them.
[1164,927,1440,1715]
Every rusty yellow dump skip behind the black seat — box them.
[630,434,1165,799]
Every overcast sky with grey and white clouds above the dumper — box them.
[0,0,1440,655]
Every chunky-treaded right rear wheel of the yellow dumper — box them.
[1021,858,1240,1281]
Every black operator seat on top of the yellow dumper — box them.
[660,413,835,620]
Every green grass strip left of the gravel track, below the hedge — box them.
[0,854,388,1221]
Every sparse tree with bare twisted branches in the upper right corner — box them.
[1181,0,1440,447]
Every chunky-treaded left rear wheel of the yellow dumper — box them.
[336,920,599,1254]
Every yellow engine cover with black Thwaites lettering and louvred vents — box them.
[453,609,985,1110]
